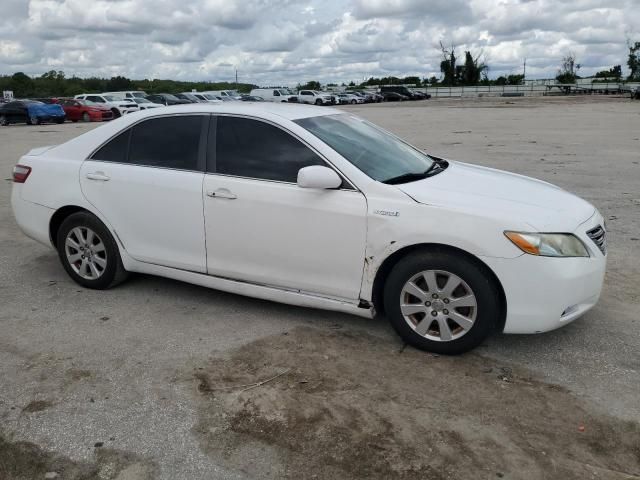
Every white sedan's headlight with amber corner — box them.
[504,232,589,257]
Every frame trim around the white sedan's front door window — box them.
[204,113,362,193]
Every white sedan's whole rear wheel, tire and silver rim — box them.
[56,212,128,290]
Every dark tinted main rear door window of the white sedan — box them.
[129,115,205,170]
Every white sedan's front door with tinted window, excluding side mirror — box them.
[203,115,367,300]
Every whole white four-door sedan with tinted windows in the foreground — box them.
[12,102,606,354]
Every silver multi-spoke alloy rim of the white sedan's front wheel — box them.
[400,270,478,342]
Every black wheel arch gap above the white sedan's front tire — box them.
[371,243,507,332]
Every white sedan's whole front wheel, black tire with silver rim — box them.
[384,250,500,355]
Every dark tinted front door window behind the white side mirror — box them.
[216,117,325,183]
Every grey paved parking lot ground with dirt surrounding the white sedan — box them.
[0,96,640,480]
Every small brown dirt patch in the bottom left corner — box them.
[0,435,156,480]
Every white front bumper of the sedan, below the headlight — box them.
[480,213,607,333]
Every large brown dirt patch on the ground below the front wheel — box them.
[191,327,640,479]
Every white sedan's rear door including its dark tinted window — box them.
[80,115,209,273]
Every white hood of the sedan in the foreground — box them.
[396,161,595,232]
